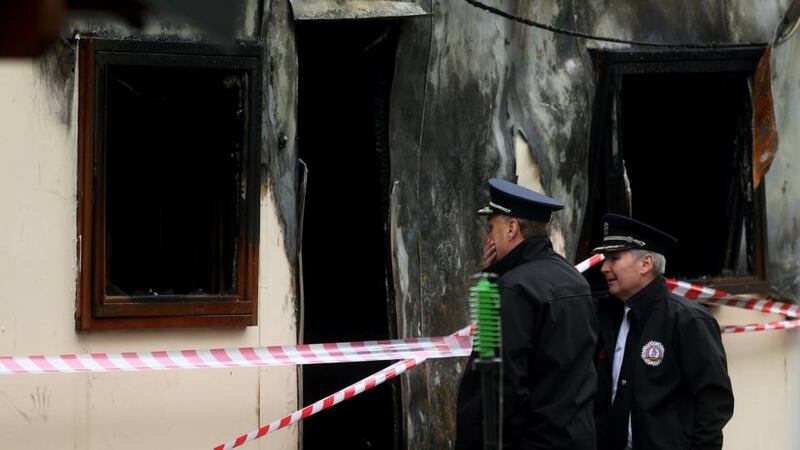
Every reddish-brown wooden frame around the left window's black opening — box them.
[75,38,262,330]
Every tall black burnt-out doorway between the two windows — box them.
[296,21,401,450]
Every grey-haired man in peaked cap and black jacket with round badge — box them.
[594,214,733,450]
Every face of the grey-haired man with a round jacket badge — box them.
[600,250,652,300]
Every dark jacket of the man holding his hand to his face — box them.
[456,237,597,450]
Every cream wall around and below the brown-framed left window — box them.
[0,59,297,450]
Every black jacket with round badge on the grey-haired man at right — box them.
[595,277,733,450]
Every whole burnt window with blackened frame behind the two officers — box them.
[579,48,766,292]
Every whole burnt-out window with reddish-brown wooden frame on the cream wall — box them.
[76,39,261,329]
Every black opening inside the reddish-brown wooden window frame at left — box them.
[106,66,246,296]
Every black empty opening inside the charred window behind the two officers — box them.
[620,73,754,278]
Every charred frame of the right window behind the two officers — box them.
[578,46,769,294]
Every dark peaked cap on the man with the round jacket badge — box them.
[592,214,678,255]
